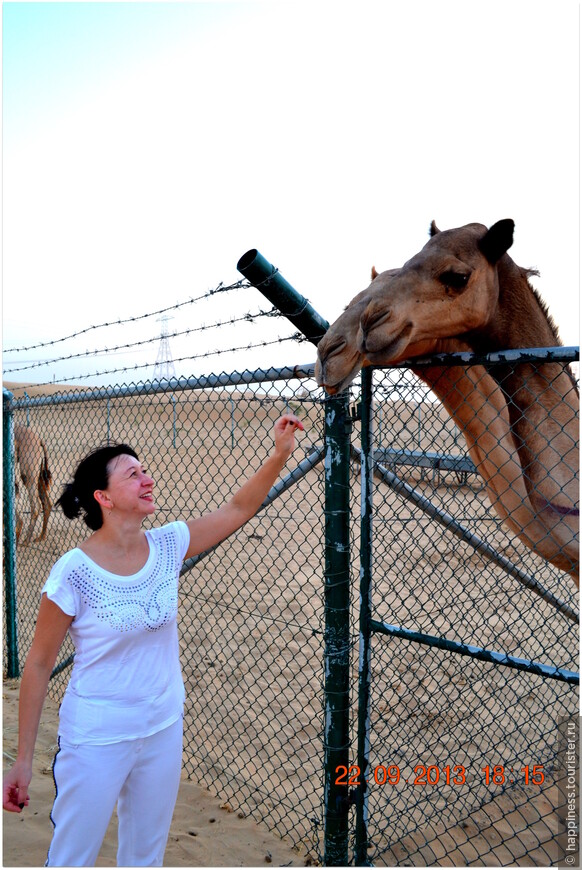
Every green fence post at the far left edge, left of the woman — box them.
[2,389,20,679]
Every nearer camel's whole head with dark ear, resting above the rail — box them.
[357,220,514,365]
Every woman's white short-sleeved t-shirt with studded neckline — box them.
[42,522,190,744]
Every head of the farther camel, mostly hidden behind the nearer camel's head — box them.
[315,267,398,396]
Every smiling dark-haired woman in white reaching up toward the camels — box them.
[4,414,303,867]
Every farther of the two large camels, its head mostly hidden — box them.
[316,225,578,581]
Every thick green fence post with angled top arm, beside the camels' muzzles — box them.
[237,249,351,867]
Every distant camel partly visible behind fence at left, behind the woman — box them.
[14,426,52,546]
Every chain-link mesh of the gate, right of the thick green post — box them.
[354,360,579,866]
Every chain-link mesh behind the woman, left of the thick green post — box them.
[5,376,323,860]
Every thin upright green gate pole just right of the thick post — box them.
[354,368,374,867]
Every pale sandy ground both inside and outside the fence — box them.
[4,378,578,866]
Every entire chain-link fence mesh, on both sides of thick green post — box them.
[5,350,578,866]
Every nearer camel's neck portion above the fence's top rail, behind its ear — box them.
[469,254,562,351]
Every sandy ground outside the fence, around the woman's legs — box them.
[2,680,305,867]
